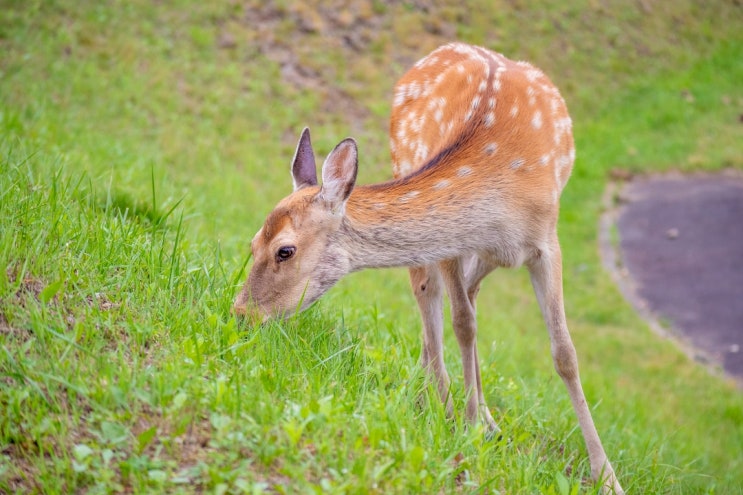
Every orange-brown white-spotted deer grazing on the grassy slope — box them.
[233,42,624,494]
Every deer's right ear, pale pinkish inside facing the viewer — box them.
[320,138,359,212]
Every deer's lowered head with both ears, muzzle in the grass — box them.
[233,128,358,320]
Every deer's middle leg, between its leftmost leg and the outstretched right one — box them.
[439,258,498,431]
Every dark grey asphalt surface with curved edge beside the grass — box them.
[616,174,743,382]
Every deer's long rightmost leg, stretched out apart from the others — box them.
[529,238,624,495]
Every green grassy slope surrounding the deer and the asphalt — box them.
[0,0,743,495]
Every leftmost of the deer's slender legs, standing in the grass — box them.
[409,265,452,415]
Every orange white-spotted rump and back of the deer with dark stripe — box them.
[390,43,575,211]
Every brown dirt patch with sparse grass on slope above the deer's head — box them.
[222,0,457,136]
